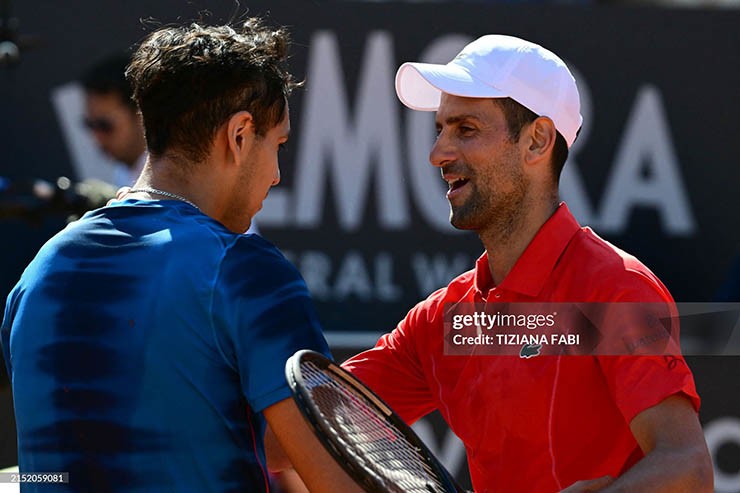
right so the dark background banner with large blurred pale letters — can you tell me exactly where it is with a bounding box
[0,0,740,491]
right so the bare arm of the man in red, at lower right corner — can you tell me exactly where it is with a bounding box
[563,395,714,493]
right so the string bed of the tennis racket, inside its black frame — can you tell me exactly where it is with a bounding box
[301,362,445,493]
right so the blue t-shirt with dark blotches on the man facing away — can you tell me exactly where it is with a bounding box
[2,200,329,492]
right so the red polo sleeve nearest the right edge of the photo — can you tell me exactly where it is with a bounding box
[597,271,701,423]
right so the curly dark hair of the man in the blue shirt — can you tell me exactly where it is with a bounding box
[126,17,300,163]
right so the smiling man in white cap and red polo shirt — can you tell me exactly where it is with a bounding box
[344,35,713,493]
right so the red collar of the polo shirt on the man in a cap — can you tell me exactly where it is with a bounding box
[475,202,581,297]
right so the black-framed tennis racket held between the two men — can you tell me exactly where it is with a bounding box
[285,350,465,493]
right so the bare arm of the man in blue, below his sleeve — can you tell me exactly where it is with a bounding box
[264,399,364,493]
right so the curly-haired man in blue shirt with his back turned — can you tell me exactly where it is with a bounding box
[1,19,356,492]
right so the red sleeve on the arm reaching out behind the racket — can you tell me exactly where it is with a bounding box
[342,303,436,424]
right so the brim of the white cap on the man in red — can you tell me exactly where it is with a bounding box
[396,62,507,111]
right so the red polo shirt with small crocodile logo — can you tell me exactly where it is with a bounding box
[343,203,699,493]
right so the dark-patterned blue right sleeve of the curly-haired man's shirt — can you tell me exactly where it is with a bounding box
[213,235,331,412]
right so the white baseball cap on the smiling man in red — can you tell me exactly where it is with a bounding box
[396,34,583,147]
